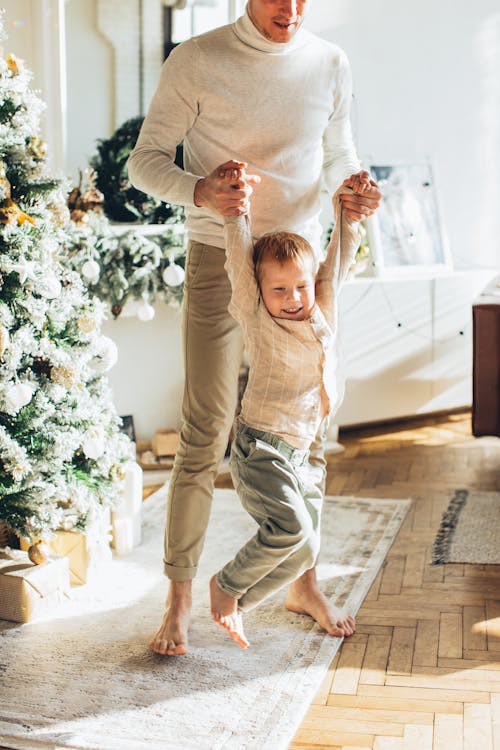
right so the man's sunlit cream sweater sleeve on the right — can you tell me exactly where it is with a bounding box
[323,50,360,195]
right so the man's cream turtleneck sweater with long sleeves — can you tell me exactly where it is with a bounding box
[128,6,359,248]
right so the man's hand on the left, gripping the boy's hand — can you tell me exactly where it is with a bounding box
[194,159,260,216]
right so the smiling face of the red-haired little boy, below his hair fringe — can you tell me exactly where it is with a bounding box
[259,258,315,320]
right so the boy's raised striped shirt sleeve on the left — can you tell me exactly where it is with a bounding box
[224,216,259,321]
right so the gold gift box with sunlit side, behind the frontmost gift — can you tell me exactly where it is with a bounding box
[20,508,112,586]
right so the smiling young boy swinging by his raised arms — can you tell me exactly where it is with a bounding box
[210,170,371,648]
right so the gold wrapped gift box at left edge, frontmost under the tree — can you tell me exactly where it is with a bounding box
[0,550,70,622]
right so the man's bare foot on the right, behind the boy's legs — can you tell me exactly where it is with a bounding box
[285,568,356,637]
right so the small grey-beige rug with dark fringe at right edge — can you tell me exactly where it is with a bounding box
[432,490,500,565]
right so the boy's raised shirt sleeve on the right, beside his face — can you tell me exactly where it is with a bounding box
[316,187,360,316]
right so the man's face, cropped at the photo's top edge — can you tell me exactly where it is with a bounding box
[248,0,308,44]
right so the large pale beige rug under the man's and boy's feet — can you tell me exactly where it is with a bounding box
[0,488,410,750]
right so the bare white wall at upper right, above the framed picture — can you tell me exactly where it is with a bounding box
[307,0,500,268]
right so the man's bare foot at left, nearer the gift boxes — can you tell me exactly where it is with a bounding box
[148,581,191,656]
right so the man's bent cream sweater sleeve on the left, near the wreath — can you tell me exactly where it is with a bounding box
[128,40,203,206]
